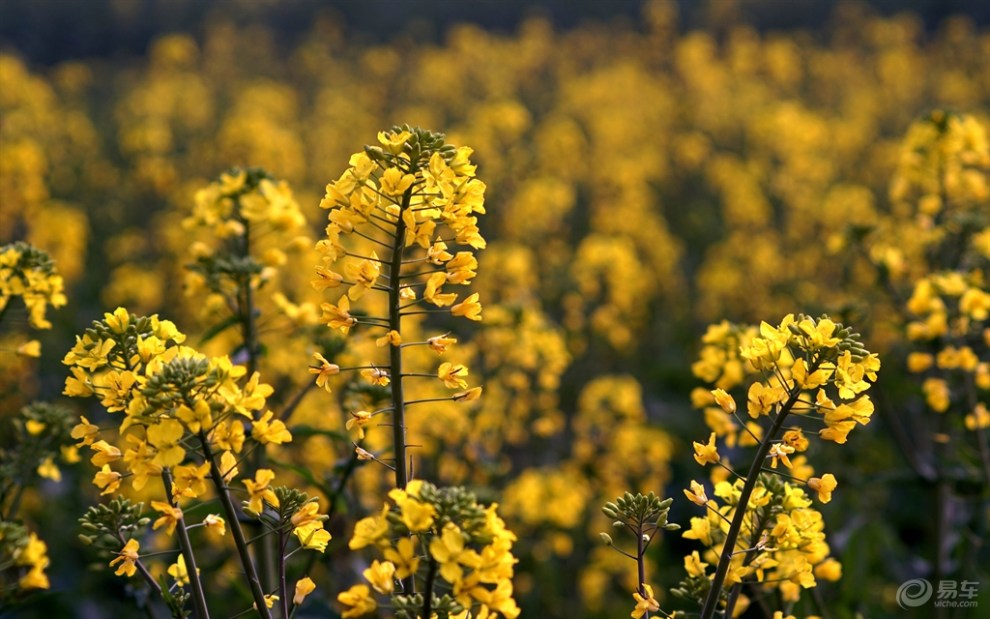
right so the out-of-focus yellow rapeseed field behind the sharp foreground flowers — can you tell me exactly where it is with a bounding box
[0,0,990,616]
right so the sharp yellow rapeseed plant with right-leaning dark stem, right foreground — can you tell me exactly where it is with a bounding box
[678,314,880,617]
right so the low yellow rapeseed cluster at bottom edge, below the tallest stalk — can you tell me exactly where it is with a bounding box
[337,479,520,619]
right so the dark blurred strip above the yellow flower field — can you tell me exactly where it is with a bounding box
[0,0,990,65]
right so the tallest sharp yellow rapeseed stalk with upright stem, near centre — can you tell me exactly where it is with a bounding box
[312,126,485,489]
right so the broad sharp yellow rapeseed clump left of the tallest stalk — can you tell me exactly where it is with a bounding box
[63,308,330,616]
